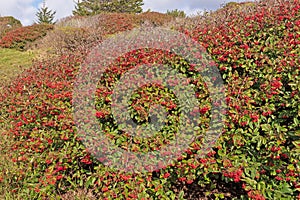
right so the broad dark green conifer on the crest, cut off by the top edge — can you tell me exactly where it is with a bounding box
[73,0,144,16]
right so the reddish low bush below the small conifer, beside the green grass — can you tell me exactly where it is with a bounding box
[0,24,53,50]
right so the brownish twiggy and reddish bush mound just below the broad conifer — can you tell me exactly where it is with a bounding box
[37,12,173,54]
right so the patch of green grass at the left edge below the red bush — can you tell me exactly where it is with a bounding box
[0,48,35,84]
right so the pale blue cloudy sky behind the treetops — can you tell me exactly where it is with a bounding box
[0,0,252,26]
